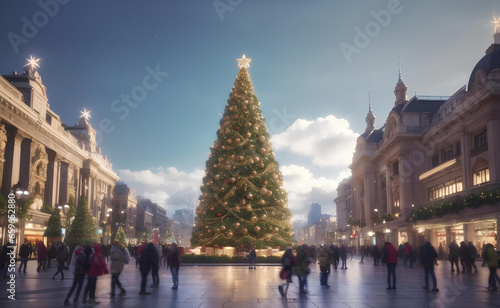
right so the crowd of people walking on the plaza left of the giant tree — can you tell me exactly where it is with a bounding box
[0,241,181,306]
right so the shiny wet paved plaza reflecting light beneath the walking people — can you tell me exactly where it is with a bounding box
[0,258,500,308]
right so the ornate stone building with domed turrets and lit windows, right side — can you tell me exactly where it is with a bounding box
[335,31,500,253]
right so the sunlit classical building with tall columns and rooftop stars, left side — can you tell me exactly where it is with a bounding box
[0,63,118,248]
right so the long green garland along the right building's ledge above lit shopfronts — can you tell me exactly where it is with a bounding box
[407,188,500,222]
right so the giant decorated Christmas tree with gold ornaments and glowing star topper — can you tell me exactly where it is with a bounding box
[191,55,294,248]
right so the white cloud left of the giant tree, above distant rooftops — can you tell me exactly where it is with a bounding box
[118,167,205,215]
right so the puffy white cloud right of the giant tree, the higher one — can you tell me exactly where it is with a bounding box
[271,115,359,167]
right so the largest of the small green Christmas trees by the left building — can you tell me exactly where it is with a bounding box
[64,198,99,248]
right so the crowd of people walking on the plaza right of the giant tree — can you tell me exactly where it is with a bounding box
[278,241,500,297]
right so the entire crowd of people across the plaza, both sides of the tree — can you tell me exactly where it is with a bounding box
[0,241,500,305]
